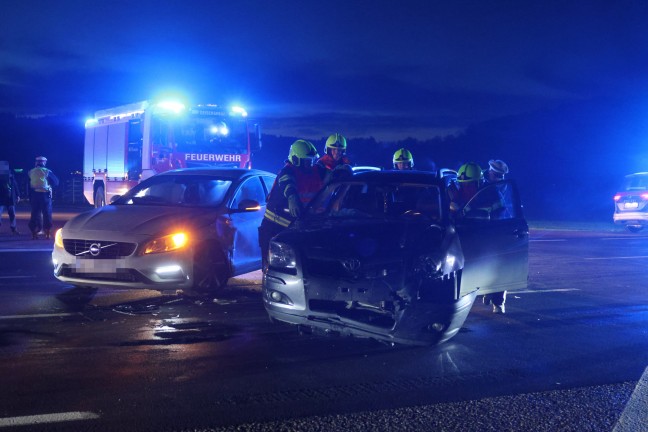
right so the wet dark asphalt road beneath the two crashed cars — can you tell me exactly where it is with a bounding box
[0,214,648,431]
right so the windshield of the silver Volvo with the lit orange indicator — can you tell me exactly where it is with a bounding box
[114,175,232,207]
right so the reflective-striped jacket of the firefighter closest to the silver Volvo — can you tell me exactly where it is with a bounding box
[263,163,327,227]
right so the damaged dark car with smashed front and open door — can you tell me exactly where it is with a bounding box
[263,171,528,345]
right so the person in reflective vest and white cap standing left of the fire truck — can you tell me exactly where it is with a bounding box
[28,156,59,240]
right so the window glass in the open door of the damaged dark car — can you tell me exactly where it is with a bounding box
[463,182,519,220]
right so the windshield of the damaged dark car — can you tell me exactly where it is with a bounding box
[308,182,441,221]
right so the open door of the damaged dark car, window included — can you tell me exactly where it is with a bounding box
[455,180,529,296]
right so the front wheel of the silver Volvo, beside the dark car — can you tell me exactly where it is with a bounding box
[192,243,229,294]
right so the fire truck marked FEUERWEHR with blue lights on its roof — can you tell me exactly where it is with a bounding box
[83,101,261,207]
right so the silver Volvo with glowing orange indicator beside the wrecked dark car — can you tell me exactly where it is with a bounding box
[52,168,275,293]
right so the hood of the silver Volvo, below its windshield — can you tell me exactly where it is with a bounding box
[64,205,223,236]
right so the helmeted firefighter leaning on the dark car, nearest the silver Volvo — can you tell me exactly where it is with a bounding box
[259,139,328,270]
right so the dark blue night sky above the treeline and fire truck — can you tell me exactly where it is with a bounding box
[5,0,648,139]
